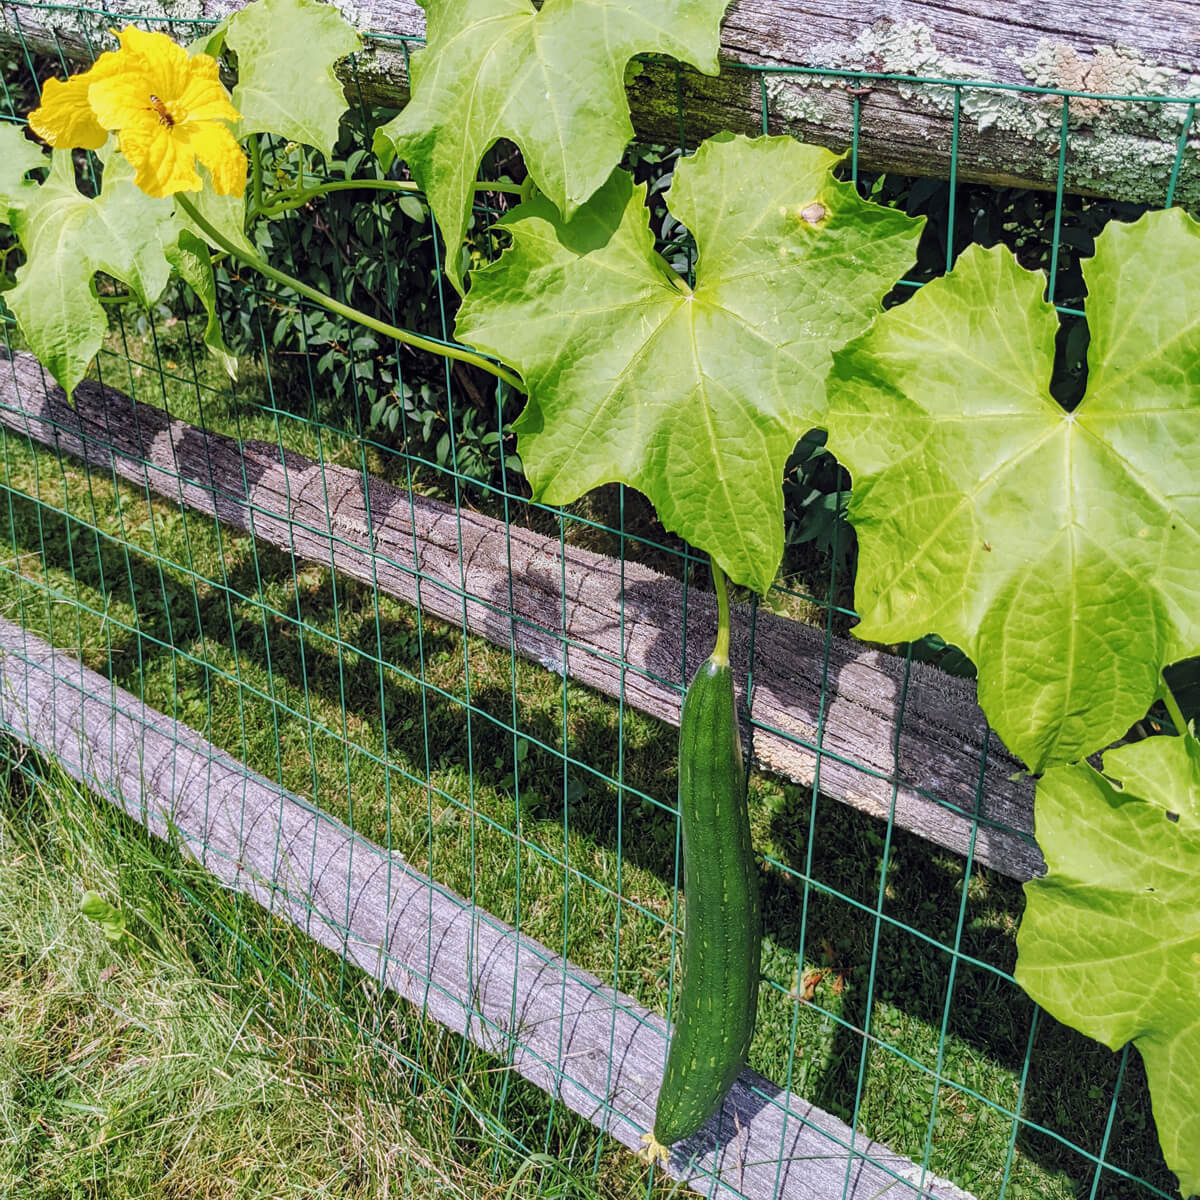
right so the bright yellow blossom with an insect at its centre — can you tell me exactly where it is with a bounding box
[29,25,246,196]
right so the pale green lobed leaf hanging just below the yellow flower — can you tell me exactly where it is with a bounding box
[5,150,174,395]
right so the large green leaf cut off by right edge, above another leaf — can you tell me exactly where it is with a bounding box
[827,210,1200,770]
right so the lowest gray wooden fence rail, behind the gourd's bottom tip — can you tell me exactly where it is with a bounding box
[0,618,970,1200]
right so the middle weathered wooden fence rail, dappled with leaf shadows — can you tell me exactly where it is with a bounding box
[0,354,1044,880]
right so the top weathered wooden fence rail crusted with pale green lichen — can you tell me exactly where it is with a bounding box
[0,0,1200,204]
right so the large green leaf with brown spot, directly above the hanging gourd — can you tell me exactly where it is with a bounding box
[457,138,922,590]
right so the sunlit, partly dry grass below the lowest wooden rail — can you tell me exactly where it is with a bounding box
[0,748,696,1200]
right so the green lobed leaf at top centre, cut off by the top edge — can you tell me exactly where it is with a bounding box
[376,0,728,290]
